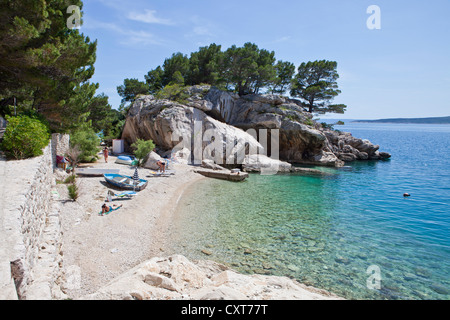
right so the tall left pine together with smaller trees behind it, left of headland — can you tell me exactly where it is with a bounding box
[0,0,124,158]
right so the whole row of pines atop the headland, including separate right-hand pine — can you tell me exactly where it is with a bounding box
[117,42,346,114]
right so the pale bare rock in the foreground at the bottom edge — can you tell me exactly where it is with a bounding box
[82,255,341,300]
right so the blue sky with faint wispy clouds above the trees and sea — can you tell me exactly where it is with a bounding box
[80,0,450,119]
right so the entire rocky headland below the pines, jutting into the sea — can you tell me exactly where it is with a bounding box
[122,86,390,167]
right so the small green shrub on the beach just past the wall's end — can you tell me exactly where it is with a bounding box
[70,126,100,162]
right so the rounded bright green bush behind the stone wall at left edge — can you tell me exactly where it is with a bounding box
[1,115,50,159]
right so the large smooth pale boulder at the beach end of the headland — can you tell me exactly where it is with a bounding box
[122,96,263,168]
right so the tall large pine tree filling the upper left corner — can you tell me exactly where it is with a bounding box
[0,0,97,131]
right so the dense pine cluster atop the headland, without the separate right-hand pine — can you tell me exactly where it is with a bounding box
[141,42,292,97]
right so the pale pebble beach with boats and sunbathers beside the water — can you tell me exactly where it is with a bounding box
[57,156,205,299]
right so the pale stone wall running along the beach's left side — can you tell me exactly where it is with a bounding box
[0,135,68,300]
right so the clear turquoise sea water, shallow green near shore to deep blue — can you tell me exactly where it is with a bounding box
[169,123,450,299]
